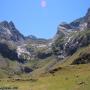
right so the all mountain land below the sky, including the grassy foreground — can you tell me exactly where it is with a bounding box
[0,9,90,90]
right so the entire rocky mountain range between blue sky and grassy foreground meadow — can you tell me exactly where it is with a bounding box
[0,9,90,81]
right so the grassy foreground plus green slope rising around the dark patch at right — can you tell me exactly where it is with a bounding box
[0,46,90,90]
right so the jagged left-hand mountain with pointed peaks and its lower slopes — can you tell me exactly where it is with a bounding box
[0,21,49,77]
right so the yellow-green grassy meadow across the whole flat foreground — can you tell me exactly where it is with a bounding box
[0,64,90,90]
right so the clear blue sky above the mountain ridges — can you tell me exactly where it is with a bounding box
[0,0,90,38]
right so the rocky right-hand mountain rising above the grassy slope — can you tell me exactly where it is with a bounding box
[52,9,90,58]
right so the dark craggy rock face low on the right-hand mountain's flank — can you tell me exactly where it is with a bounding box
[64,30,90,55]
